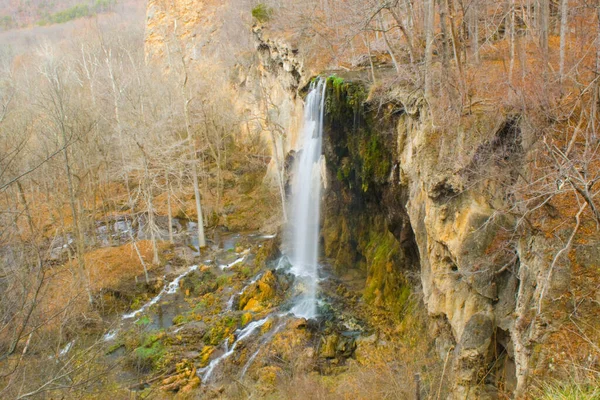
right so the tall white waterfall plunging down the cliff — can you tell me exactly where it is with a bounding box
[289,79,327,318]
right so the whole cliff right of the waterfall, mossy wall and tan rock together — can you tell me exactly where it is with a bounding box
[323,78,596,399]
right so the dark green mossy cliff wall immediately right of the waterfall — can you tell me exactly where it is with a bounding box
[322,75,412,315]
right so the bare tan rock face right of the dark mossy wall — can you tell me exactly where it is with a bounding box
[397,102,531,398]
